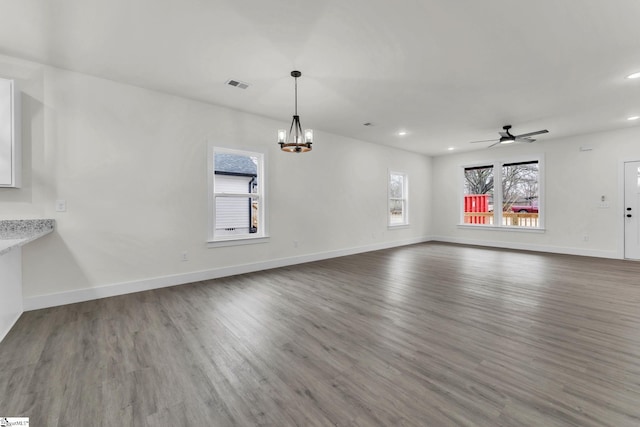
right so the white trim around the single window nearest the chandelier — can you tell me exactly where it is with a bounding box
[207,143,269,244]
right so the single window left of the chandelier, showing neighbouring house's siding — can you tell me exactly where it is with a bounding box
[209,147,265,242]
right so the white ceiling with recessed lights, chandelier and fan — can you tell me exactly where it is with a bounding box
[0,0,640,155]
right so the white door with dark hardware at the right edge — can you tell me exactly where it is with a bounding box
[624,162,640,260]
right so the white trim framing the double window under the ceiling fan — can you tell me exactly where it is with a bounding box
[457,154,547,233]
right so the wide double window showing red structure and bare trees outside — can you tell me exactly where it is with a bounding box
[462,159,543,229]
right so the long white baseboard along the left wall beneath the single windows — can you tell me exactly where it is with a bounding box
[24,237,432,311]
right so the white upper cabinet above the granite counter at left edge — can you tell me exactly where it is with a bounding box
[0,78,22,187]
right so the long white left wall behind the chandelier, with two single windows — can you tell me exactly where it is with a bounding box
[0,61,431,308]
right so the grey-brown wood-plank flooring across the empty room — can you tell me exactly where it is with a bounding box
[0,243,640,427]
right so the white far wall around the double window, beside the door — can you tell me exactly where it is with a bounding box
[432,127,640,258]
